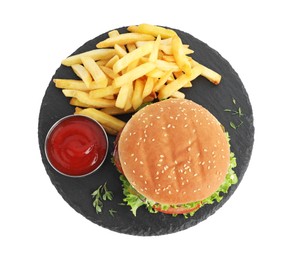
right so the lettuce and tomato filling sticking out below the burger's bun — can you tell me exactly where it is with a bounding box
[113,133,238,217]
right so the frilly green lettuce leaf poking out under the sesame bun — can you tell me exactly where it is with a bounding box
[120,133,238,218]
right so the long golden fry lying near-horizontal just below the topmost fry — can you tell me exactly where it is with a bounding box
[96,33,155,48]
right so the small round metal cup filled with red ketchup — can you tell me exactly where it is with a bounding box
[45,115,108,177]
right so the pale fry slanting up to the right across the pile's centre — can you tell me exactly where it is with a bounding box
[114,62,156,87]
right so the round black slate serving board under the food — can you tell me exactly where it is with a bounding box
[38,27,254,236]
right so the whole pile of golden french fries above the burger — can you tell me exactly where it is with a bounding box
[54,24,221,135]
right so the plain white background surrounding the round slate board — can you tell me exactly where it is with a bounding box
[0,0,289,260]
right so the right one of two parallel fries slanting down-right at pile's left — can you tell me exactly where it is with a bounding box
[81,56,108,87]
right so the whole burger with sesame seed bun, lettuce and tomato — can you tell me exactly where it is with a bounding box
[114,99,237,217]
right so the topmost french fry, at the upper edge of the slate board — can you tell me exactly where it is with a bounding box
[127,24,176,38]
